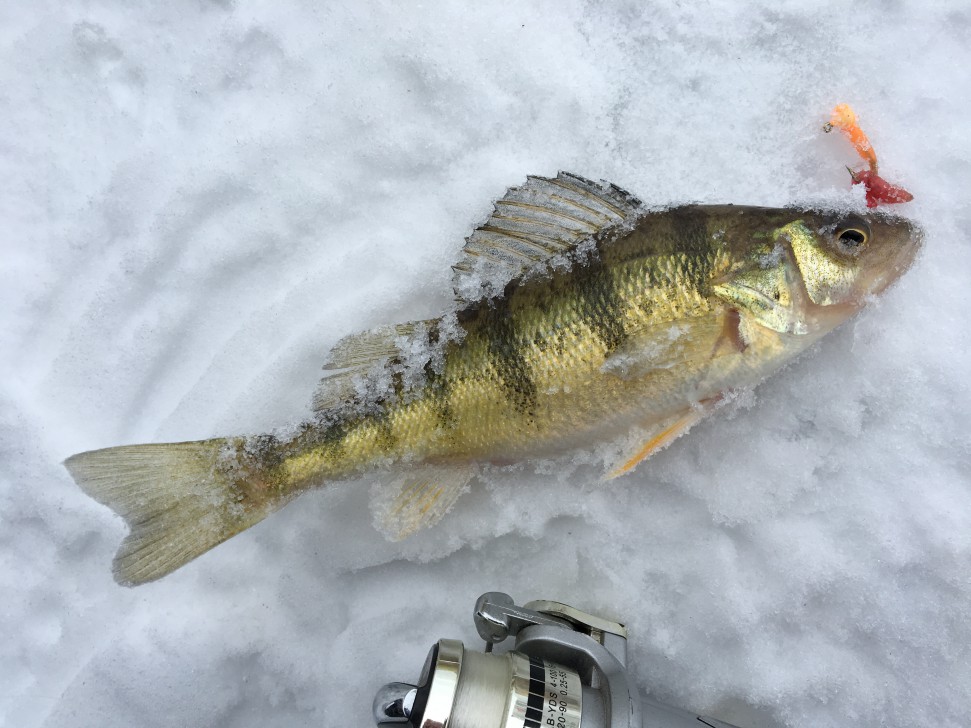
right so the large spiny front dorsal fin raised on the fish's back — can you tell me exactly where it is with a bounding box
[452,172,642,302]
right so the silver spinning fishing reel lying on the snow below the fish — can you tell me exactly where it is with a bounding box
[374,592,737,728]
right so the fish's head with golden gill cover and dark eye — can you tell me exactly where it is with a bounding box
[715,210,922,336]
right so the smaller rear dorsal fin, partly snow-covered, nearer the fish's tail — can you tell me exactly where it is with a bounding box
[313,319,439,412]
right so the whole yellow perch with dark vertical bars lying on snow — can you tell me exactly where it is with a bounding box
[64,172,922,586]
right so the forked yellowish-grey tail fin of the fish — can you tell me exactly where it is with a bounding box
[64,439,285,586]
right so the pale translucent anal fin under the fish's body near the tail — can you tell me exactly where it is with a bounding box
[372,465,475,541]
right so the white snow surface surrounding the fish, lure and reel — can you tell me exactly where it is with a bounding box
[0,0,971,728]
